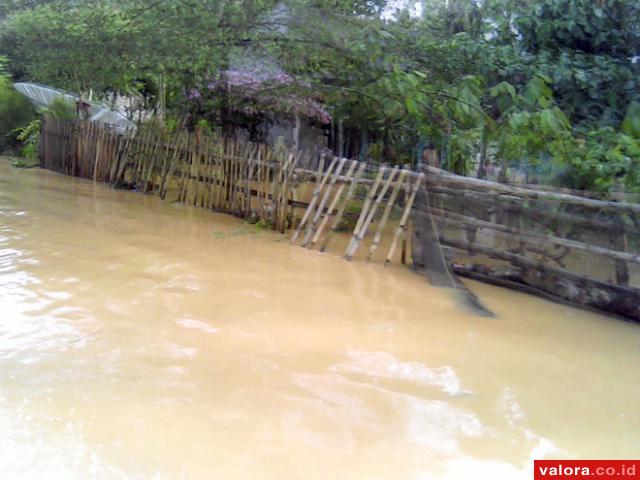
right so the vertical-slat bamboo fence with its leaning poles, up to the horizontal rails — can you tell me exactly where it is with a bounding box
[40,119,423,264]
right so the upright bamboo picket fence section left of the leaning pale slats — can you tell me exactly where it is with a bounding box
[40,120,299,232]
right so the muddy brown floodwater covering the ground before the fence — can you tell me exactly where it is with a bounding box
[0,160,640,480]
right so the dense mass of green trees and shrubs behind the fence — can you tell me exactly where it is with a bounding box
[0,0,640,192]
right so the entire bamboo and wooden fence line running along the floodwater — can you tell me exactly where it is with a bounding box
[40,119,640,319]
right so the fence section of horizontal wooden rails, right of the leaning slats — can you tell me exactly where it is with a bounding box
[414,167,640,320]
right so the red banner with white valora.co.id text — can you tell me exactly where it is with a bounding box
[533,460,640,480]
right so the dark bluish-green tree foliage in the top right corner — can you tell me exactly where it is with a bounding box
[485,0,640,128]
